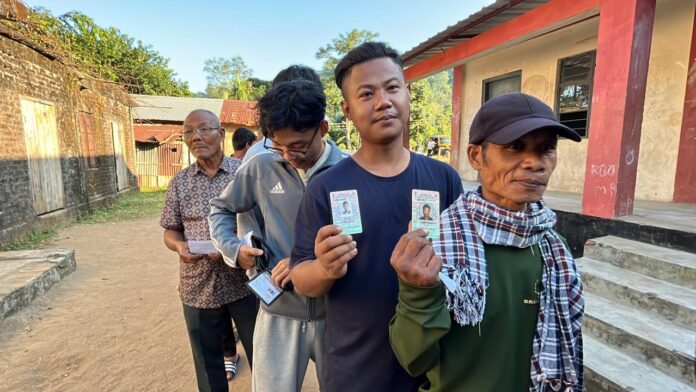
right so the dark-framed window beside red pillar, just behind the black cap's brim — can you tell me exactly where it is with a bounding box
[556,51,595,138]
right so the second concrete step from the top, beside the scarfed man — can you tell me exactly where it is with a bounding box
[577,257,696,329]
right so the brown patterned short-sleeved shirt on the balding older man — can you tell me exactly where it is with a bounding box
[160,157,251,309]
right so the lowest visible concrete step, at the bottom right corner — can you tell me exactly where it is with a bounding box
[583,335,696,392]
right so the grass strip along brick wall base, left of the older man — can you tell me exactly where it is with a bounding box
[79,191,165,223]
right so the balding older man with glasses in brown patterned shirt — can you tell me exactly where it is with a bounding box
[160,110,258,391]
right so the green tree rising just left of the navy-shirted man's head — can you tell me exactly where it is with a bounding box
[316,29,379,148]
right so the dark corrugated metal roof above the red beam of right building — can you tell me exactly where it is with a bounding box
[401,0,549,67]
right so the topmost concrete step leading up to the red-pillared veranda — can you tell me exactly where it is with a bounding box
[584,236,696,290]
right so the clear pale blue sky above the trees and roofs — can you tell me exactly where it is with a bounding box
[24,0,493,92]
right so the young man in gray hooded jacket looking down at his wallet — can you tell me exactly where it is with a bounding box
[209,72,345,392]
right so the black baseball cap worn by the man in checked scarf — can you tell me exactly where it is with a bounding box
[469,93,581,144]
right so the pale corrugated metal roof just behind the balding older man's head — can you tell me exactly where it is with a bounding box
[131,94,224,122]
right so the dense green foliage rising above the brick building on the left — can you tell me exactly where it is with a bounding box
[24,8,191,96]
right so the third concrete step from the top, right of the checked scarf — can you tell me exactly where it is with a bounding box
[583,292,696,384]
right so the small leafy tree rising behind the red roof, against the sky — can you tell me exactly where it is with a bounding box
[203,56,271,101]
